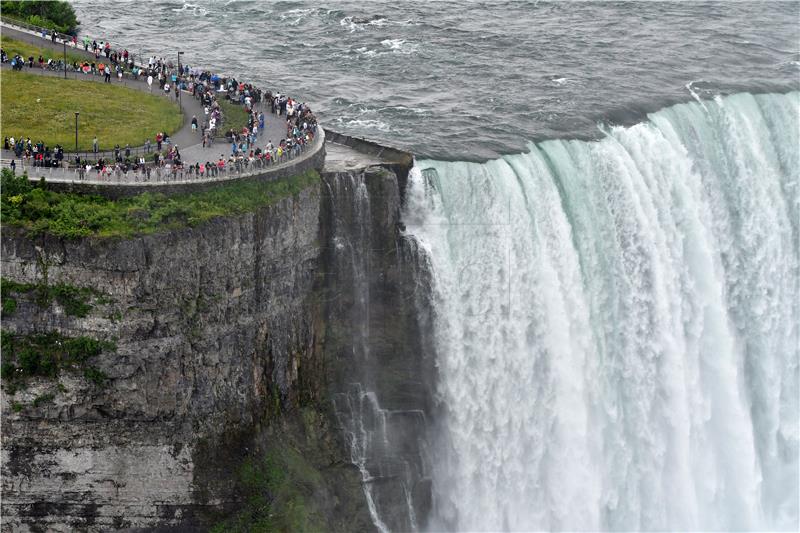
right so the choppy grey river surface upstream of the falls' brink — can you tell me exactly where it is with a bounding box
[73,0,800,161]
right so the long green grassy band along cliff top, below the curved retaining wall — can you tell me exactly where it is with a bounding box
[0,169,319,238]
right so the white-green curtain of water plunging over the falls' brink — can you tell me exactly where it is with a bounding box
[404,93,800,531]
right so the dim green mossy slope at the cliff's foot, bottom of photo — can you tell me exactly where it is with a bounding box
[206,406,372,533]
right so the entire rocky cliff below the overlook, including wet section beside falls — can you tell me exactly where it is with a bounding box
[2,164,429,531]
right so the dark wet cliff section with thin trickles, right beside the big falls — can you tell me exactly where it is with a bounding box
[321,167,435,531]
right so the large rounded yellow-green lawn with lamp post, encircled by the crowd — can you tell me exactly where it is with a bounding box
[0,70,183,151]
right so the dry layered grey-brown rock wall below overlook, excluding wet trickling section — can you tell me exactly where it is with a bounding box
[2,187,324,531]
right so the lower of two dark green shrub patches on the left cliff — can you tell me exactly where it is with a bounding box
[2,331,116,394]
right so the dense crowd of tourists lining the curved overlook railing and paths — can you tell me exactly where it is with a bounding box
[1,21,317,179]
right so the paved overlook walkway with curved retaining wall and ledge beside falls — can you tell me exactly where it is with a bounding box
[0,20,413,198]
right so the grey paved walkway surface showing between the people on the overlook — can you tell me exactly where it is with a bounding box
[0,22,286,163]
